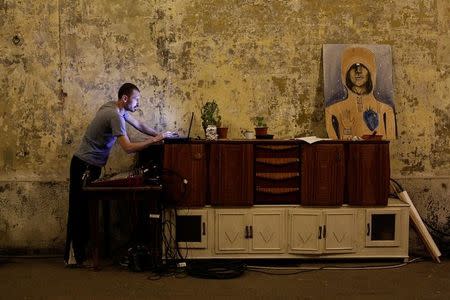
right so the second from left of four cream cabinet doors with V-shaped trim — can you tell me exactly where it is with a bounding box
[249,209,286,253]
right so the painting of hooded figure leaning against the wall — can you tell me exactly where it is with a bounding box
[324,45,396,140]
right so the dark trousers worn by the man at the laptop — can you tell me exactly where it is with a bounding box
[64,156,101,264]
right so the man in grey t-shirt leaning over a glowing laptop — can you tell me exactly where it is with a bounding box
[64,83,174,265]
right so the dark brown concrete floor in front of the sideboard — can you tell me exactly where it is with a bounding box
[0,258,450,299]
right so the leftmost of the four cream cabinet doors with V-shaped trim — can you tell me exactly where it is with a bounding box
[215,209,250,253]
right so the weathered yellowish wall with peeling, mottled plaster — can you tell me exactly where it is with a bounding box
[0,0,450,253]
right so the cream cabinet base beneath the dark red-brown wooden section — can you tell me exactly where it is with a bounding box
[166,199,409,261]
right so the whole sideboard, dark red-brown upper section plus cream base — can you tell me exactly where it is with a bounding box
[141,140,409,260]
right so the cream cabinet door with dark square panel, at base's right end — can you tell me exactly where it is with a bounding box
[366,208,402,247]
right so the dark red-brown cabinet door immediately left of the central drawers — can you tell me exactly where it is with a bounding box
[210,144,253,206]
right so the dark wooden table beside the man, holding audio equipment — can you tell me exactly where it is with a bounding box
[83,185,162,271]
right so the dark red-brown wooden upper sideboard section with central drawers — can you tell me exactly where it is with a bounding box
[149,140,390,207]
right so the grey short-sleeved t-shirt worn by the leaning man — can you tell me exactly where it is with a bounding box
[74,101,128,167]
